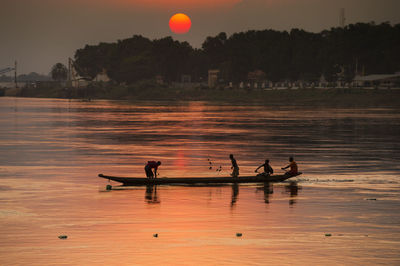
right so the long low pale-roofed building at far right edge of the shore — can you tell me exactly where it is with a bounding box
[353,72,400,87]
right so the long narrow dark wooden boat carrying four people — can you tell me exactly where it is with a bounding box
[99,173,301,186]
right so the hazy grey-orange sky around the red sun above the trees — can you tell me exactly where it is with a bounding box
[0,0,400,74]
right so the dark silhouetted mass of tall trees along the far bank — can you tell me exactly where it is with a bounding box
[75,23,400,84]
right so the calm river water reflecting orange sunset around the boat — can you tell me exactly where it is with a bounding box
[0,97,400,265]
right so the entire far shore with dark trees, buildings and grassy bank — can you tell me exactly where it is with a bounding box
[0,22,400,106]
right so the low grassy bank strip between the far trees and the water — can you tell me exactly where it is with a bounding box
[4,84,400,106]
